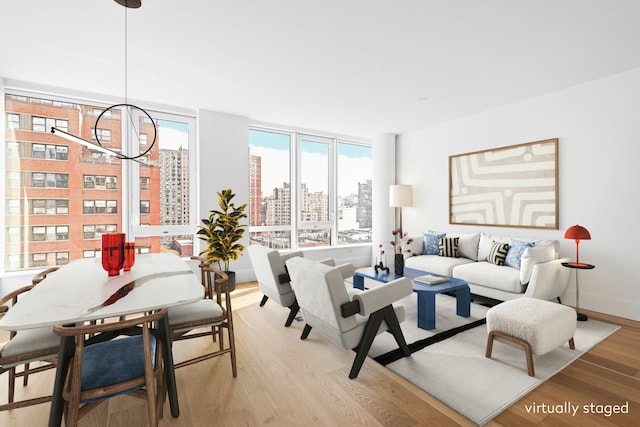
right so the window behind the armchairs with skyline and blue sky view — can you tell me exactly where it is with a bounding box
[249,127,373,249]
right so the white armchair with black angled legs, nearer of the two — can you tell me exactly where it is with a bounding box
[286,258,413,379]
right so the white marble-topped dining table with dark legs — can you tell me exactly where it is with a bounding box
[0,253,204,426]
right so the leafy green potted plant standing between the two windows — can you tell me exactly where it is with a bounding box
[197,189,247,290]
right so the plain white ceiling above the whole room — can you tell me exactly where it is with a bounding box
[0,0,640,137]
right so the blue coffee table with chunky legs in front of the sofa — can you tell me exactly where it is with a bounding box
[353,267,471,329]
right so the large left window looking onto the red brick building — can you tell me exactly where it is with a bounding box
[0,90,199,272]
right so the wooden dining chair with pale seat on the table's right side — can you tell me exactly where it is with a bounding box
[167,257,238,378]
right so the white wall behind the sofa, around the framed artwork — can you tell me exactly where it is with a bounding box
[396,69,640,320]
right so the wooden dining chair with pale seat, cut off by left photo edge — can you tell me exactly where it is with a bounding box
[0,285,60,411]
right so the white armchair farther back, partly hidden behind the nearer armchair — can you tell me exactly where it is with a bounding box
[247,245,304,327]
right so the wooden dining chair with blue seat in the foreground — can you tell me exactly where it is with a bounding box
[53,308,168,427]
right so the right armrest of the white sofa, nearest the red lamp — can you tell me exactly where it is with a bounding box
[524,258,571,300]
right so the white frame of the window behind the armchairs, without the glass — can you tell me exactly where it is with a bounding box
[248,124,373,250]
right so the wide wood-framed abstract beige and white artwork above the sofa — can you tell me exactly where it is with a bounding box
[449,138,558,230]
